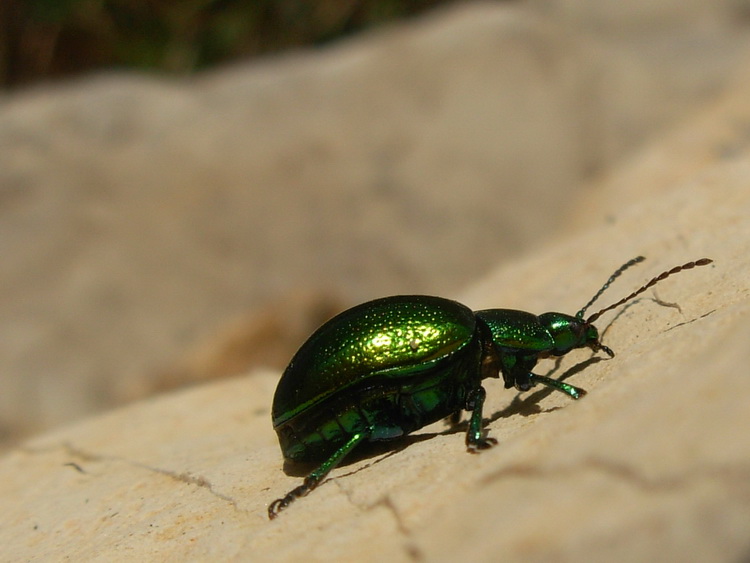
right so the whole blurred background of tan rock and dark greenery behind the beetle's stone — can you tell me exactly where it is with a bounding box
[0,0,750,446]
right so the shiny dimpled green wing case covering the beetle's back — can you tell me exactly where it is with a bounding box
[272,296,476,428]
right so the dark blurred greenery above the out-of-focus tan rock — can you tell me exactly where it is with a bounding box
[0,0,464,88]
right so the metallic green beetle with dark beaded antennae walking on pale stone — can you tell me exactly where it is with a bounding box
[268,256,712,519]
